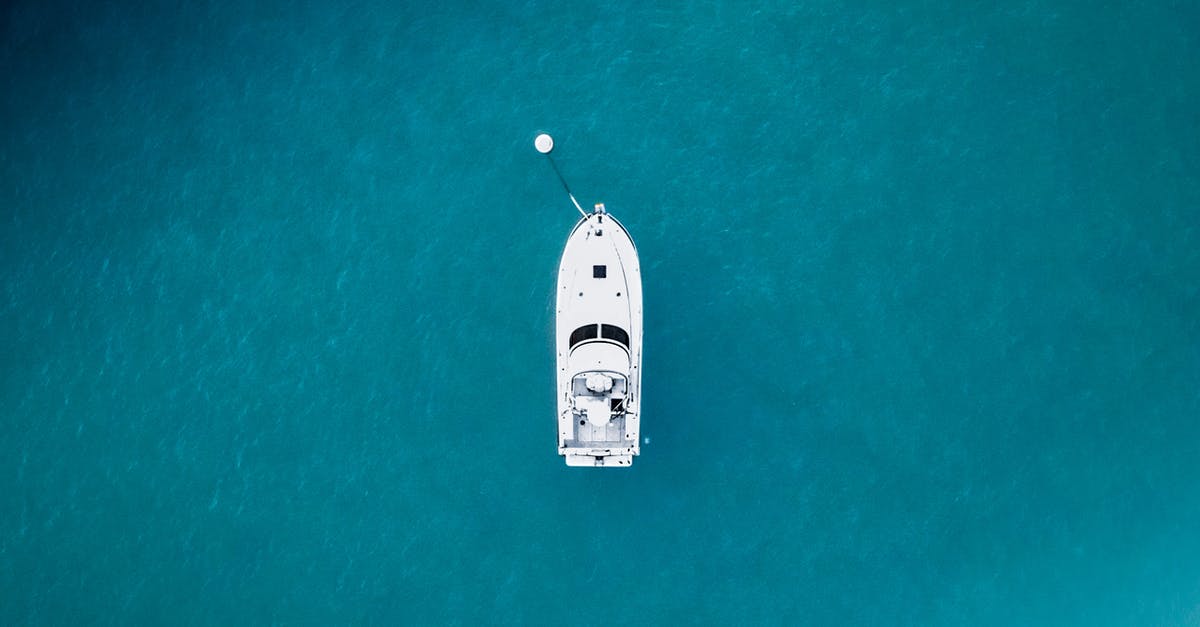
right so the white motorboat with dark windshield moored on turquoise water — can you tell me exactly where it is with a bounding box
[554,202,642,466]
